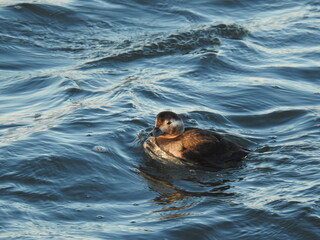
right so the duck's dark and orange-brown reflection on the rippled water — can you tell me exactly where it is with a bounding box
[139,160,242,220]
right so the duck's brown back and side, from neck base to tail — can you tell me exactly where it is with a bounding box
[155,128,249,168]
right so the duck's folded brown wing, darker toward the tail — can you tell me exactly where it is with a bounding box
[181,129,249,168]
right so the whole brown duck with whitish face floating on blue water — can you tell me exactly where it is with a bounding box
[143,111,250,168]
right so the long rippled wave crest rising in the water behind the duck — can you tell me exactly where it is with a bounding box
[82,24,248,66]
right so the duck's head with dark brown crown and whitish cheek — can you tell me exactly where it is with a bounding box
[150,111,184,138]
